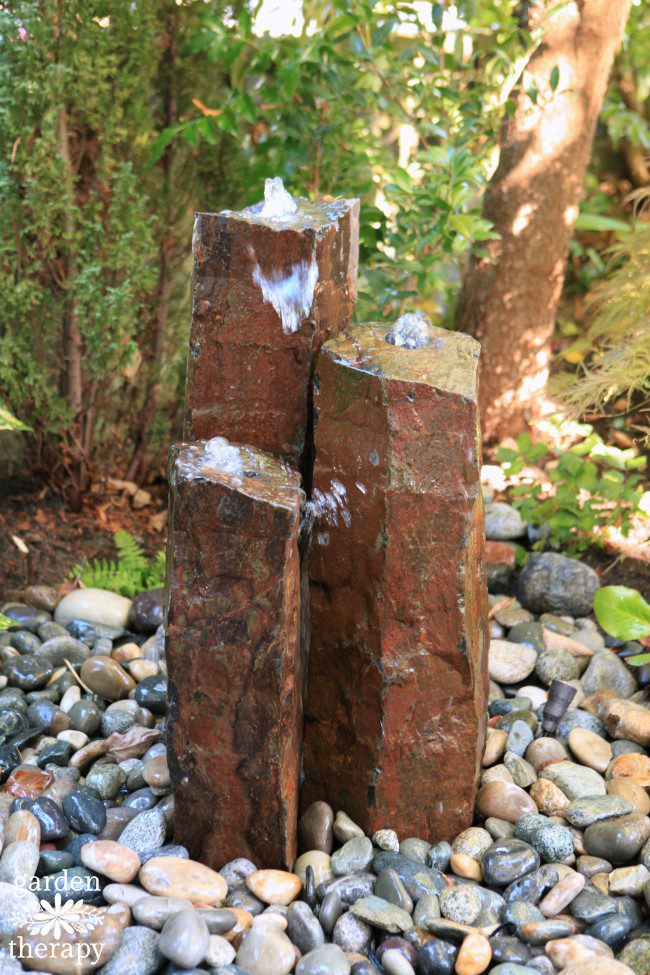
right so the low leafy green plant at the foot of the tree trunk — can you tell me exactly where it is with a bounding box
[497,424,645,554]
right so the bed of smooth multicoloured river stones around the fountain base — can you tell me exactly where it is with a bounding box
[0,548,650,975]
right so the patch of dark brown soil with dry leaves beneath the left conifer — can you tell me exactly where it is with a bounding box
[0,480,167,600]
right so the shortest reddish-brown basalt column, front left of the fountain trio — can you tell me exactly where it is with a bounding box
[165,438,304,869]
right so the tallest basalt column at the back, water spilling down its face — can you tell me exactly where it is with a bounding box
[185,200,359,467]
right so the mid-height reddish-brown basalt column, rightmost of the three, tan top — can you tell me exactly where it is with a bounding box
[303,324,488,841]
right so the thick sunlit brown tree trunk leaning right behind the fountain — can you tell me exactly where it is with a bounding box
[456,0,631,441]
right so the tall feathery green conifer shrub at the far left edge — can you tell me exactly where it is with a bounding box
[0,0,156,480]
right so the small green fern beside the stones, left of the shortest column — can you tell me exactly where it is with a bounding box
[70,531,165,599]
